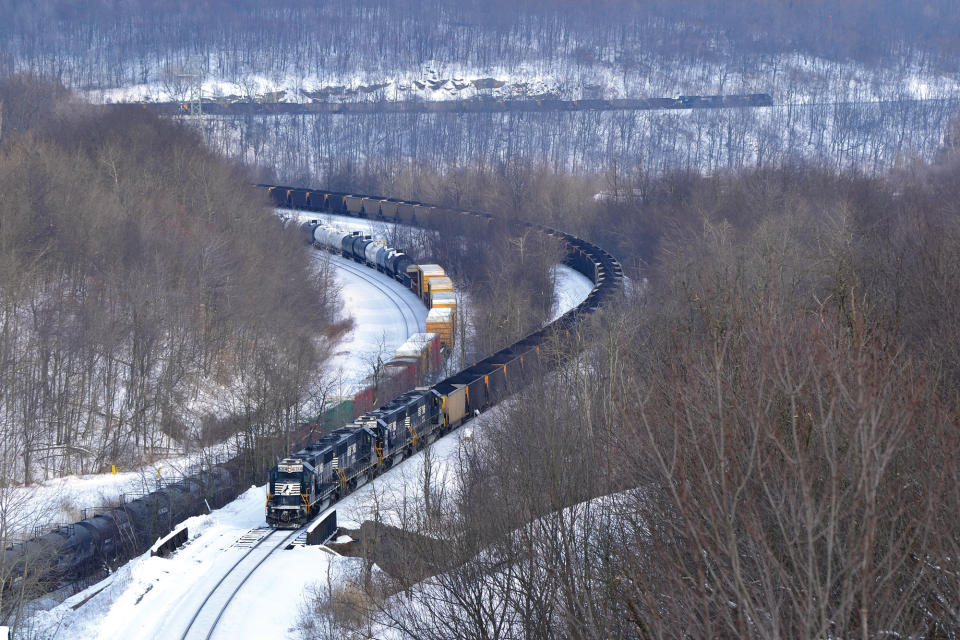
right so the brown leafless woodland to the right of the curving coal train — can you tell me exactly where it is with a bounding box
[301,138,960,638]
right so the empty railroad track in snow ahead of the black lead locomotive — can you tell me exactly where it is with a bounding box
[180,529,300,640]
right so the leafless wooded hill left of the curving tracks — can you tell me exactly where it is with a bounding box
[0,78,336,483]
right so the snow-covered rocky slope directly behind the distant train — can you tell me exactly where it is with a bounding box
[84,54,960,104]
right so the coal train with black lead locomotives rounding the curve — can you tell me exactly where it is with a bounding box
[265,187,623,529]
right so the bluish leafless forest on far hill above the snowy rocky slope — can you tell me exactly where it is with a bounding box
[0,0,960,99]
